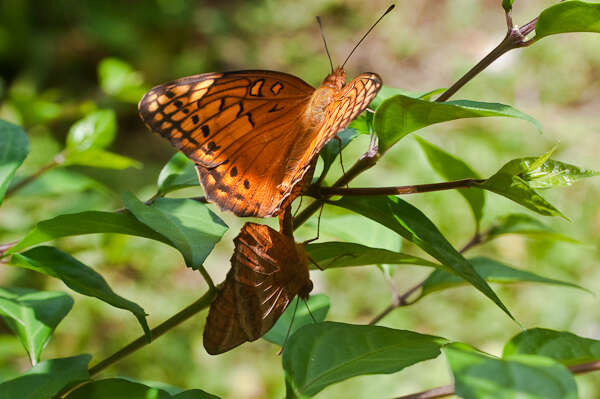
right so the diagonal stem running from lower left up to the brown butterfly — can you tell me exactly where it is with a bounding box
[89,289,216,377]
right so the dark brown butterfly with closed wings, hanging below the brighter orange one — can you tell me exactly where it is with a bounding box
[204,223,313,355]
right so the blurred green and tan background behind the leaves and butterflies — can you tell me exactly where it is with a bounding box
[0,0,600,398]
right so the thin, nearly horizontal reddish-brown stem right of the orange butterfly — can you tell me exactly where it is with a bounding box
[317,179,485,196]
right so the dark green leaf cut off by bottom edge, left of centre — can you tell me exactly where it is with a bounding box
[66,378,219,399]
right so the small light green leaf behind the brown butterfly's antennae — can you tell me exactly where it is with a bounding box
[263,294,331,346]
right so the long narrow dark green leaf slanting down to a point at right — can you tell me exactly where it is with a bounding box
[332,196,513,318]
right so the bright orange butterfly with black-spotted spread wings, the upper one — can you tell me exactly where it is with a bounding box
[138,67,381,217]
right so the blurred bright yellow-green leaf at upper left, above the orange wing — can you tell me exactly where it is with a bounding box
[98,58,147,104]
